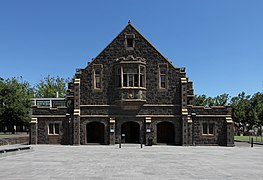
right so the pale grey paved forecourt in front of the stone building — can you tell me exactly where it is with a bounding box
[0,144,263,180]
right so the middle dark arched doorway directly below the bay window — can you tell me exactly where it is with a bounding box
[121,121,140,143]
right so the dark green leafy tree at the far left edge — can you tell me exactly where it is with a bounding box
[0,77,33,130]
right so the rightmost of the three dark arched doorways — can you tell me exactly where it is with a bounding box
[157,122,174,144]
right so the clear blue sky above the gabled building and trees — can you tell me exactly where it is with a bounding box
[0,0,263,96]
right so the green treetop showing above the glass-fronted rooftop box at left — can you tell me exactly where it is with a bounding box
[35,75,69,98]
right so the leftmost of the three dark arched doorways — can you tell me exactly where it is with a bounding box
[86,122,104,144]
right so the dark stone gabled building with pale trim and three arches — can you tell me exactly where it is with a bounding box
[30,23,234,146]
